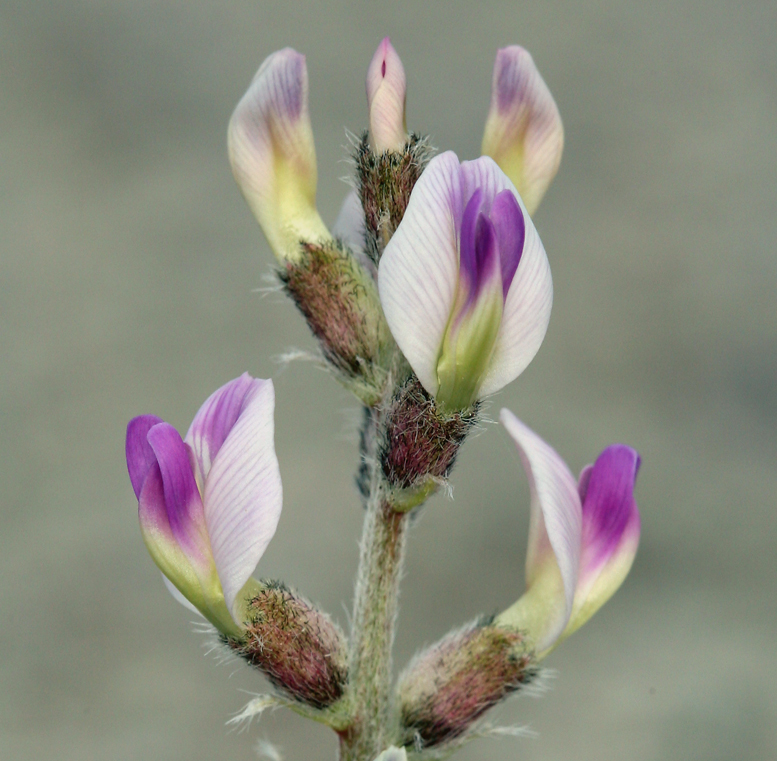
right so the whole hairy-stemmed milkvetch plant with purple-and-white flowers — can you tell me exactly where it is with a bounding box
[126,38,640,761]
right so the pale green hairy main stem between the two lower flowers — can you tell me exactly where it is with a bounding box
[340,416,408,761]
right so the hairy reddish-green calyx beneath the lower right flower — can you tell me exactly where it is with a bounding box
[398,622,536,750]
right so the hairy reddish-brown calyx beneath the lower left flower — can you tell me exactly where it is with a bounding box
[227,582,348,709]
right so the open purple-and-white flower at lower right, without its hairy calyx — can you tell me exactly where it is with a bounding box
[495,409,640,657]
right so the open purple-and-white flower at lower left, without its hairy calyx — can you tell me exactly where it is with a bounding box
[126,373,282,635]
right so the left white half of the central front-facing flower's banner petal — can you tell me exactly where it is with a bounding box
[378,151,464,395]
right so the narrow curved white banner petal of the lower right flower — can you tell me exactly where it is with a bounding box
[497,409,582,653]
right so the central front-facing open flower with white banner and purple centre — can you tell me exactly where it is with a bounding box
[378,151,553,409]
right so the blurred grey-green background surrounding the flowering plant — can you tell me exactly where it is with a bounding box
[0,0,777,761]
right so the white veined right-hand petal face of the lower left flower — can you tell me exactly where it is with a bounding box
[203,379,283,624]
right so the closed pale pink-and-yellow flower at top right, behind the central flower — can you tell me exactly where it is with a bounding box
[481,45,564,214]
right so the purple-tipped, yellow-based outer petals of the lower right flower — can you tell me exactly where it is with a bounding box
[563,444,640,638]
